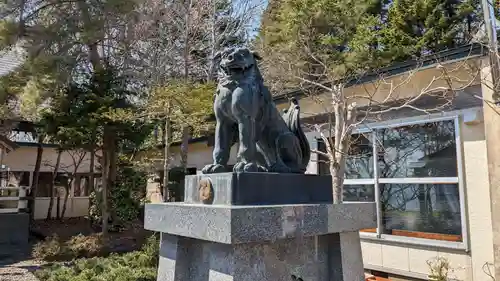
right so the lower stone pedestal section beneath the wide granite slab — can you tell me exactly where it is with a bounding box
[157,232,364,281]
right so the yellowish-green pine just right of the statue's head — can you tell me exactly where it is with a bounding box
[256,0,384,92]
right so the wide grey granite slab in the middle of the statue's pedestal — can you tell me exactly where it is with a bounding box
[144,203,376,244]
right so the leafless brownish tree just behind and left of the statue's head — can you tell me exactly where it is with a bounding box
[129,0,264,200]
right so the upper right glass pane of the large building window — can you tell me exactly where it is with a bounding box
[377,120,457,178]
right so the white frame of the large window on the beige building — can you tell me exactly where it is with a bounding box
[317,108,468,251]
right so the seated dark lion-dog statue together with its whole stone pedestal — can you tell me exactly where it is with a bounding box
[144,49,376,281]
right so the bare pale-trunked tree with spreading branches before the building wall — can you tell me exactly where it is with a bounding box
[279,42,479,203]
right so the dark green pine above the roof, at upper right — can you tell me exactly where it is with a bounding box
[382,0,480,61]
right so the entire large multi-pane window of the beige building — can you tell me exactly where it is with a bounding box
[318,117,464,242]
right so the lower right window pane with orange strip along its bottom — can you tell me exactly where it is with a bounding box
[380,184,462,242]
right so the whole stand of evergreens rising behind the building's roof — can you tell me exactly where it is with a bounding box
[256,0,482,93]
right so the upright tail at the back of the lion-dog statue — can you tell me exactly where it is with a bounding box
[283,99,311,173]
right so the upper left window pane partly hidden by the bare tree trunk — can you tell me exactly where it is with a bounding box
[318,133,373,179]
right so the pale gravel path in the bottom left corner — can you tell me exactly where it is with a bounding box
[0,260,40,281]
